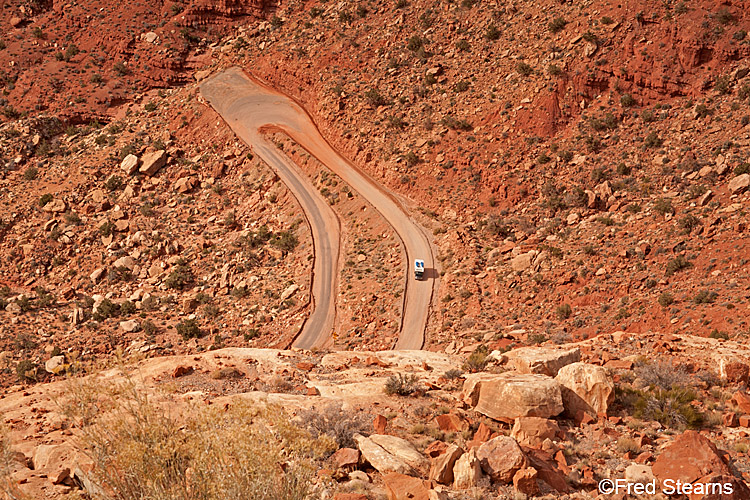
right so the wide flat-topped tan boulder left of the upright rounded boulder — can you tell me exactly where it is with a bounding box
[467,372,563,422]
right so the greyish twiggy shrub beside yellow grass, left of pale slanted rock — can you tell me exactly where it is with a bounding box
[297,403,372,448]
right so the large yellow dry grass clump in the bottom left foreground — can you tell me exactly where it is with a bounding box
[64,376,335,500]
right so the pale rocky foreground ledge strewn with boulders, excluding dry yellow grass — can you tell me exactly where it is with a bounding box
[5,332,750,500]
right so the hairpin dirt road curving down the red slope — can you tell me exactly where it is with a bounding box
[200,68,437,349]
